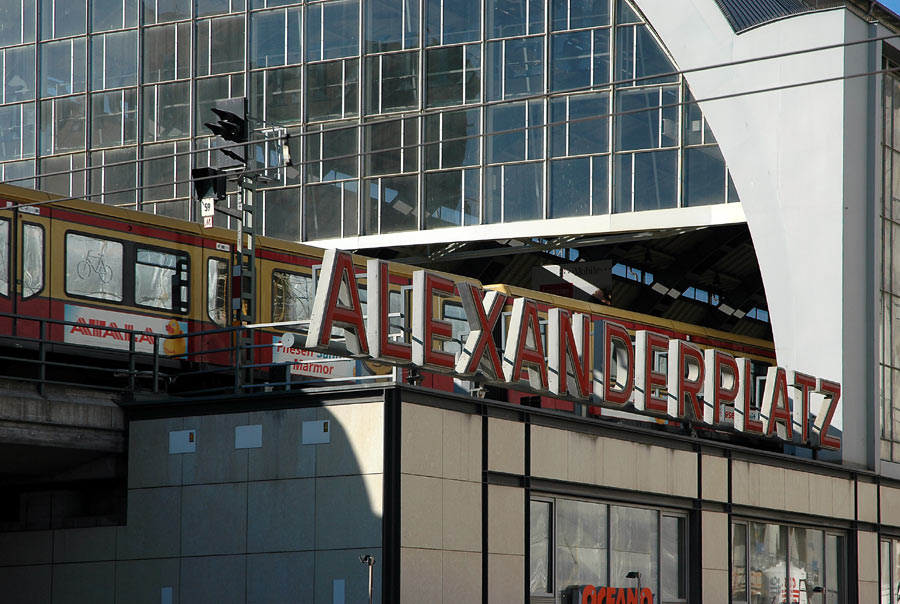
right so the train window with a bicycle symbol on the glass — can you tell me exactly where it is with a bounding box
[66,233,123,302]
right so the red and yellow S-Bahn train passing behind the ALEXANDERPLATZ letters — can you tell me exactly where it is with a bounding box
[0,185,775,409]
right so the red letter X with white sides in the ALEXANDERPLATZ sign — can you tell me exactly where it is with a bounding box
[456,283,506,380]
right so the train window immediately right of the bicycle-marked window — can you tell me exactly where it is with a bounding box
[134,248,188,312]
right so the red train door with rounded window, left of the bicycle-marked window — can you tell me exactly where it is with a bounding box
[13,208,50,338]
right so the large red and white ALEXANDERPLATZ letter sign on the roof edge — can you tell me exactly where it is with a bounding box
[306,250,841,450]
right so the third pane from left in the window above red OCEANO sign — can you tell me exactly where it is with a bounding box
[608,506,659,601]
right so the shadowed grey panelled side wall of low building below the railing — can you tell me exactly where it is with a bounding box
[0,403,384,604]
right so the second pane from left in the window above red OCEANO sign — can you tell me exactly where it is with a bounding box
[556,499,609,593]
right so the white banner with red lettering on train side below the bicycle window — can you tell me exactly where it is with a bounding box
[63,304,187,356]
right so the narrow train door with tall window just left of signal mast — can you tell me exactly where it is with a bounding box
[201,243,231,365]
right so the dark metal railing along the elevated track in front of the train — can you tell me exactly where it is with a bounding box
[0,313,397,400]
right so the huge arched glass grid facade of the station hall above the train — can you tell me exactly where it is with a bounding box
[0,0,737,240]
